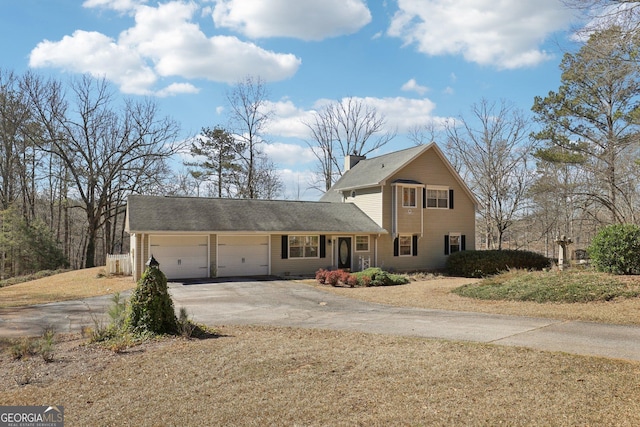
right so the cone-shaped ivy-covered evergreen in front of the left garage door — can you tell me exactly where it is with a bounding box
[127,257,178,334]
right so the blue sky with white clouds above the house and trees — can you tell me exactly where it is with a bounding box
[0,0,592,199]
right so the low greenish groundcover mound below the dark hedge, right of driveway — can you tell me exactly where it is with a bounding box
[452,270,640,303]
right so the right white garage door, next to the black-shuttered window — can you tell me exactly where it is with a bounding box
[218,236,269,277]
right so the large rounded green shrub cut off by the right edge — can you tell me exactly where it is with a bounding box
[588,224,640,274]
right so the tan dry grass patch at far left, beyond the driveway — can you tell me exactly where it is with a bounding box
[0,267,136,308]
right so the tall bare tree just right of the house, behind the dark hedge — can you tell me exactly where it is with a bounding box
[446,99,533,249]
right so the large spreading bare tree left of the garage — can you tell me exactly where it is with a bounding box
[24,76,178,267]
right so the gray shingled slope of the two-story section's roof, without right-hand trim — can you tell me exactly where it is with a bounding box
[320,144,431,202]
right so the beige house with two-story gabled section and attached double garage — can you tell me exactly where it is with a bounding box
[126,143,477,280]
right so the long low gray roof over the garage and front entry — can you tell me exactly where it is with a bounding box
[127,195,387,234]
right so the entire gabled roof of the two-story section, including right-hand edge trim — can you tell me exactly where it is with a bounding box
[320,142,478,205]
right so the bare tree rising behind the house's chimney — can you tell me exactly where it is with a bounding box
[304,97,396,191]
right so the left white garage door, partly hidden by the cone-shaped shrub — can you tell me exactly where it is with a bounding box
[151,236,209,279]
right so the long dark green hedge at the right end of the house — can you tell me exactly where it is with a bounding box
[446,250,551,277]
